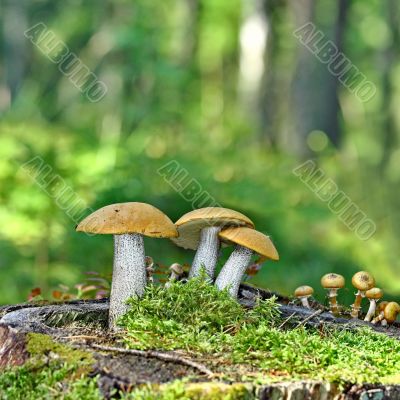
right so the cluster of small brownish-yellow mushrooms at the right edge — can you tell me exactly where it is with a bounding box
[294,271,400,326]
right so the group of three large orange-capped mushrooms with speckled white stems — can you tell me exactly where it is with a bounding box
[76,202,279,329]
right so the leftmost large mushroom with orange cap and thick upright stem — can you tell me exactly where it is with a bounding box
[76,202,178,329]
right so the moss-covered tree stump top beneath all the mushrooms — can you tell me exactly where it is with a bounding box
[0,285,400,400]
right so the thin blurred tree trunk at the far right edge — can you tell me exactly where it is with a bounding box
[380,0,400,174]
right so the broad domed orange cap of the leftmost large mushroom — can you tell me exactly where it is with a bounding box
[76,202,178,238]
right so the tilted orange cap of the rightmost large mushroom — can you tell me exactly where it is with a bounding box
[219,227,279,260]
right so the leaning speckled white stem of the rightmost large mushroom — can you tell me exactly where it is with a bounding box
[215,245,253,298]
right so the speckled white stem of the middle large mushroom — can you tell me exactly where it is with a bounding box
[189,226,221,280]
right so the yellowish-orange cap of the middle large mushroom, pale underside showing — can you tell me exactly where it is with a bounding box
[172,207,254,250]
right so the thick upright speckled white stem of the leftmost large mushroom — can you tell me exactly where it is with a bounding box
[108,233,146,330]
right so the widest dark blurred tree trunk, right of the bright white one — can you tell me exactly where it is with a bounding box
[289,0,348,156]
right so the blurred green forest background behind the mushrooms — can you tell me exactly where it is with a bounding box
[0,0,400,310]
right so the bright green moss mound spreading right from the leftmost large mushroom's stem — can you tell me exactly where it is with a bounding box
[121,279,400,384]
